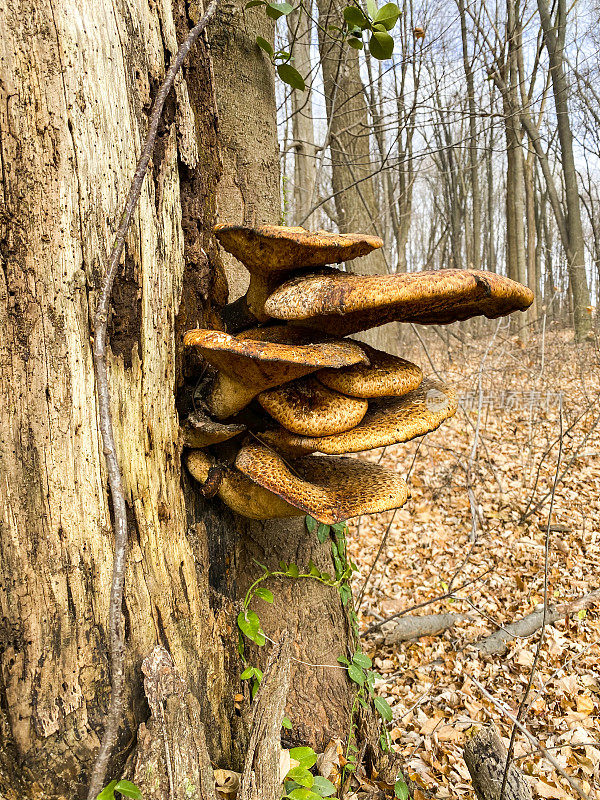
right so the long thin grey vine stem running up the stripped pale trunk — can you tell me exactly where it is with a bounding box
[88,0,217,800]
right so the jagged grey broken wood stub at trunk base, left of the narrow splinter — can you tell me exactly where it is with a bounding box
[134,646,217,800]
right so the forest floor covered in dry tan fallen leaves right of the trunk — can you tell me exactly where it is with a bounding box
[349,323,600,799]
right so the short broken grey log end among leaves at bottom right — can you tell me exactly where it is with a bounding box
[463,724,532,800]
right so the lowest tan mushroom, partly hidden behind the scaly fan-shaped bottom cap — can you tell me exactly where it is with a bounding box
[186,450,303,519]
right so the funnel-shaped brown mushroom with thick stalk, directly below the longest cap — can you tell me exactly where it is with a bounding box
[184,325,368,419]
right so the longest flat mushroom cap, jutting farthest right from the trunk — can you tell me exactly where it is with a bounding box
[264,269,533,336]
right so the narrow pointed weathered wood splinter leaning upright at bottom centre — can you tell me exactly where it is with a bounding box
[238,633,291,800]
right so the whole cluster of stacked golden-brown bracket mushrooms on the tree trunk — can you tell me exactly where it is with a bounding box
[182,225,533,524]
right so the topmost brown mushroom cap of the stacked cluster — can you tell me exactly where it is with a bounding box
[214,225,383,275]
